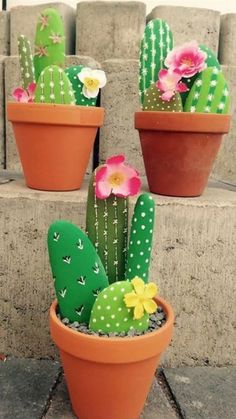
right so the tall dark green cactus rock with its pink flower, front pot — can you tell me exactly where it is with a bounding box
[86,155,141,283]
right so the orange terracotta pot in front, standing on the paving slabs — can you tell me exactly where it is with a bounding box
[50,298,174,419]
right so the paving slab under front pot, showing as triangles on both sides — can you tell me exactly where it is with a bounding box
[44,379,178,419]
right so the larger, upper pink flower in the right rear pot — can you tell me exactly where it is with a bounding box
[165,41,207,77]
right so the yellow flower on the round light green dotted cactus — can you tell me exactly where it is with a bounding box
[124,276,157,320]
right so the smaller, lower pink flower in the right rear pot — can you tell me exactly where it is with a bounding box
[156,69,188,101]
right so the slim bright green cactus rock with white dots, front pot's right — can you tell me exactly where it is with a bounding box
[126,193,155,283]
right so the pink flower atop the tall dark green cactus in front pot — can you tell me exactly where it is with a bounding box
[95,155,141,199]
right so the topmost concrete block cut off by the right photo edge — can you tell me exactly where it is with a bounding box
[219,13,236,65]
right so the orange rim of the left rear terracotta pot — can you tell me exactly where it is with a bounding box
[7,102,104,127]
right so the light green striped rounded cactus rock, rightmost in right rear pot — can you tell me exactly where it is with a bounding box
[184,67,229,114]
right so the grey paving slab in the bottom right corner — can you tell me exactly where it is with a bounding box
[164,366,236,419]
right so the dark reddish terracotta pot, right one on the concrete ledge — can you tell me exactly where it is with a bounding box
[135,111,231,197]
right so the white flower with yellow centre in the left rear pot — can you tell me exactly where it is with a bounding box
[77,67,107,99]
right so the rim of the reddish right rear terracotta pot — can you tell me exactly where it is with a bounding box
[135,111,231,134]
